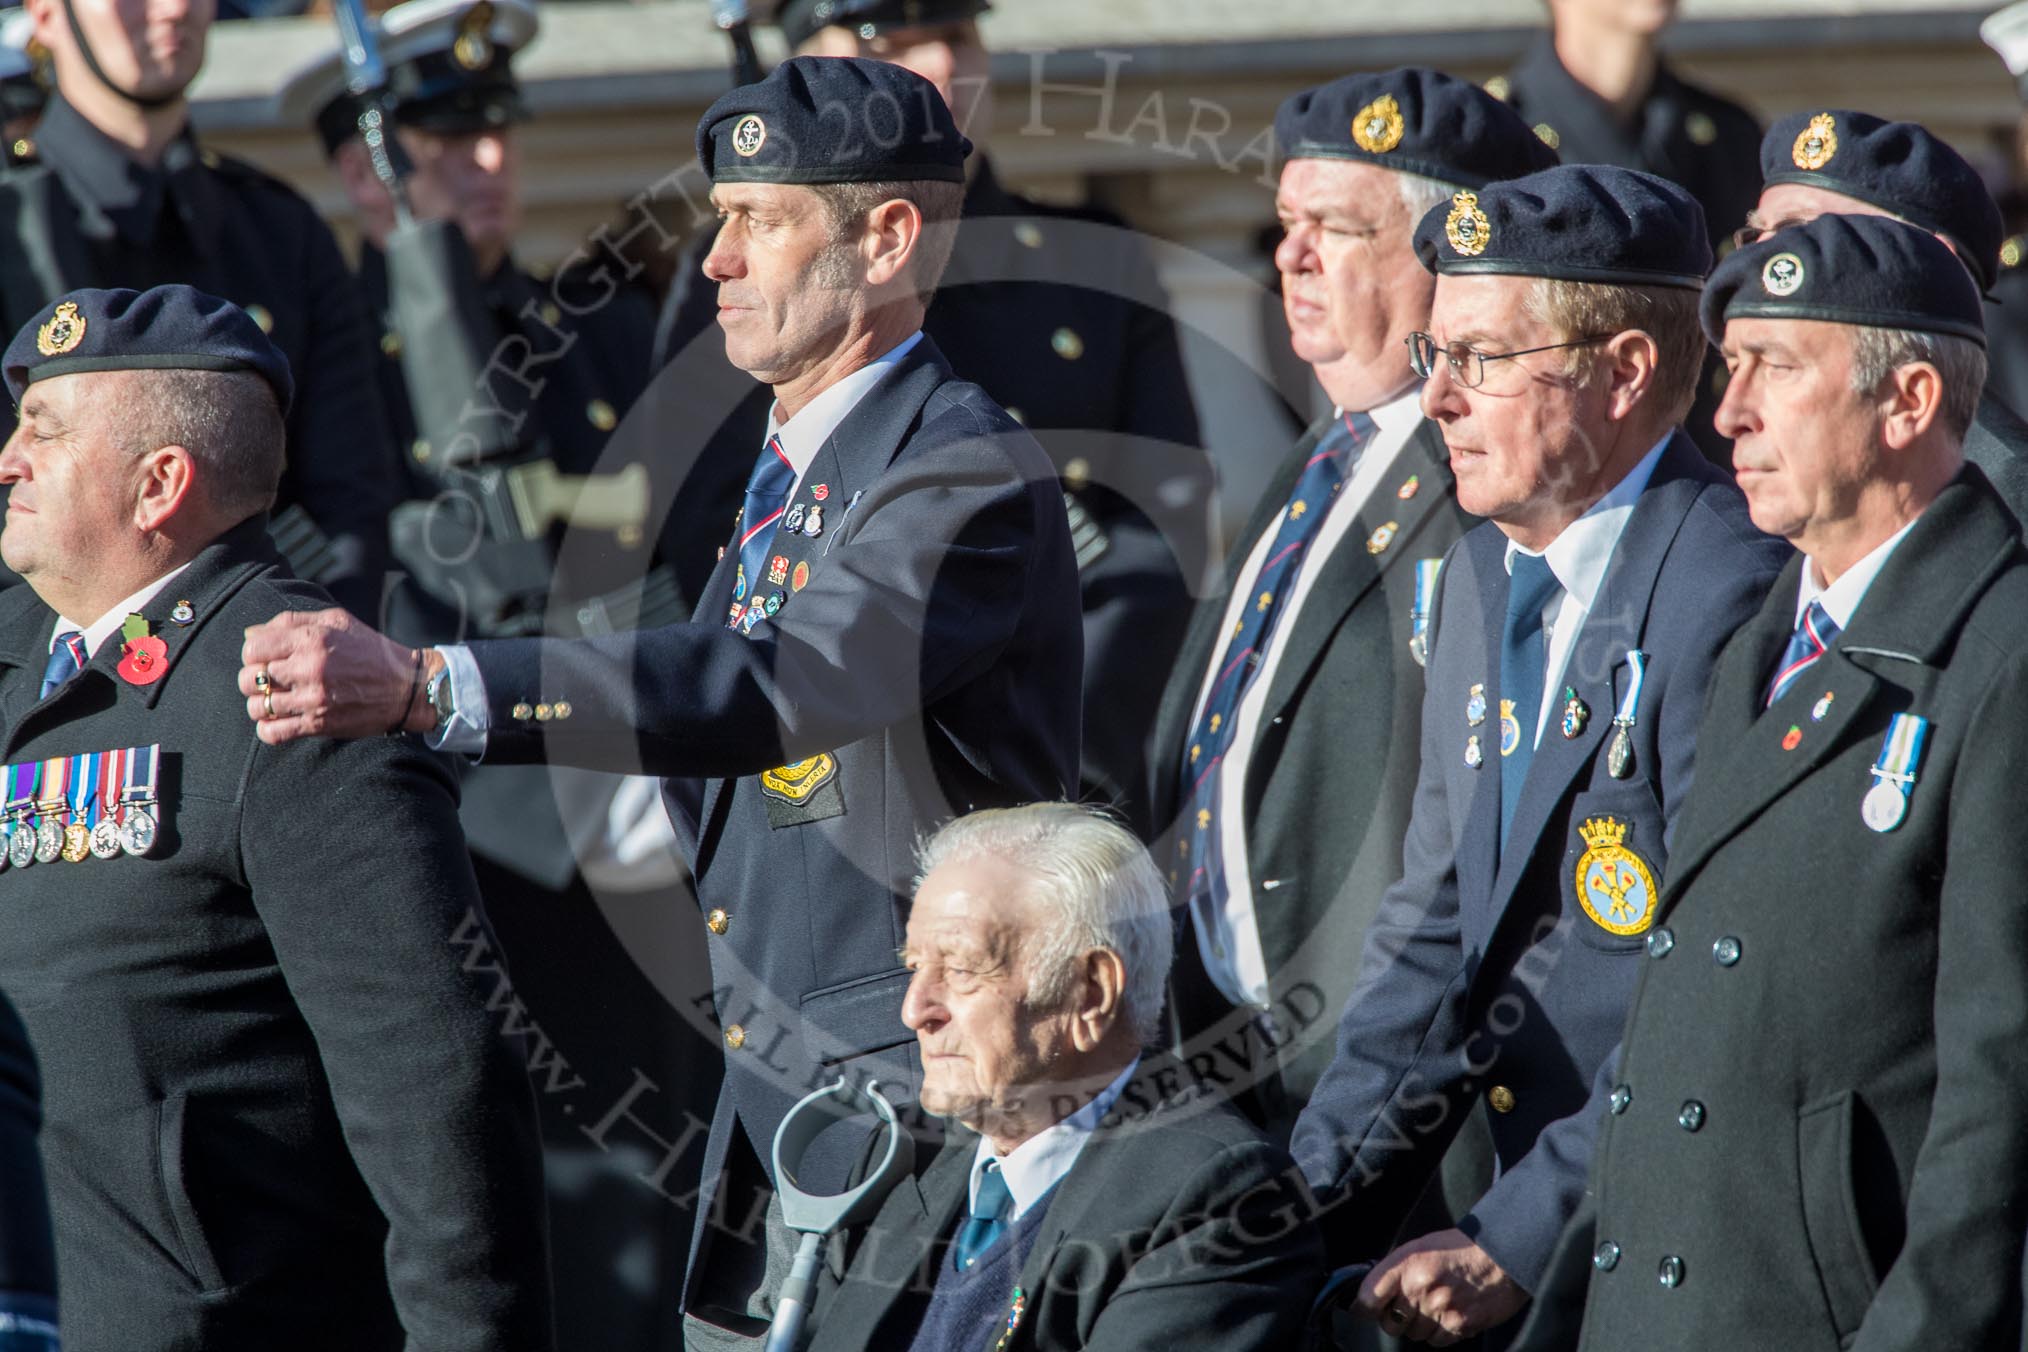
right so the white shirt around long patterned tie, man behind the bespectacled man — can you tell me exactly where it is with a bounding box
[1190,387,1422,1007]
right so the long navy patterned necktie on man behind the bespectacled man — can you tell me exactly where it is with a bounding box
[1176,414,1373,934]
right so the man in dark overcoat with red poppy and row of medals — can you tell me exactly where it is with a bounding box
[0,286,552,1352]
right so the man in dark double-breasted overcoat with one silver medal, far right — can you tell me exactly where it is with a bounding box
[1541,208,2028,1352]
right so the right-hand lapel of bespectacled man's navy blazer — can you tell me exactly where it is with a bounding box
[1493,432,1708,914]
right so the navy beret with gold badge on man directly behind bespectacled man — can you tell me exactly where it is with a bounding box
[1274,65,1555,189]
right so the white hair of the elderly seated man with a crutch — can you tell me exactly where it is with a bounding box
[915,803,1176,1044]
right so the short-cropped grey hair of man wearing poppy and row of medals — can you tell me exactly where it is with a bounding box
[105,369,286,517]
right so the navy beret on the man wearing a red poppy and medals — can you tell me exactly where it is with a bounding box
[6,284,296,414]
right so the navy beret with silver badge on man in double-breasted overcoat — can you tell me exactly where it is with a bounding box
[1697,215,1985,347]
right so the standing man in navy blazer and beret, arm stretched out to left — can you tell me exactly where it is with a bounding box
[241,57,1083,1348]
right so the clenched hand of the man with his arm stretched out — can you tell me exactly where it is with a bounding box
[239,608,444,746]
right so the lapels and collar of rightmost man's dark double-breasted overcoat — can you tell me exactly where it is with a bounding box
[1655,464,2022,922]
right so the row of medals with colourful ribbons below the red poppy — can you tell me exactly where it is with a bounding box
[0,746,162,870]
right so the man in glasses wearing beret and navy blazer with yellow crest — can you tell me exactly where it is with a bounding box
[1292,166,1787,1342]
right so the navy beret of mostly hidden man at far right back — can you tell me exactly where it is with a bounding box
[1760,107,2008,286]
